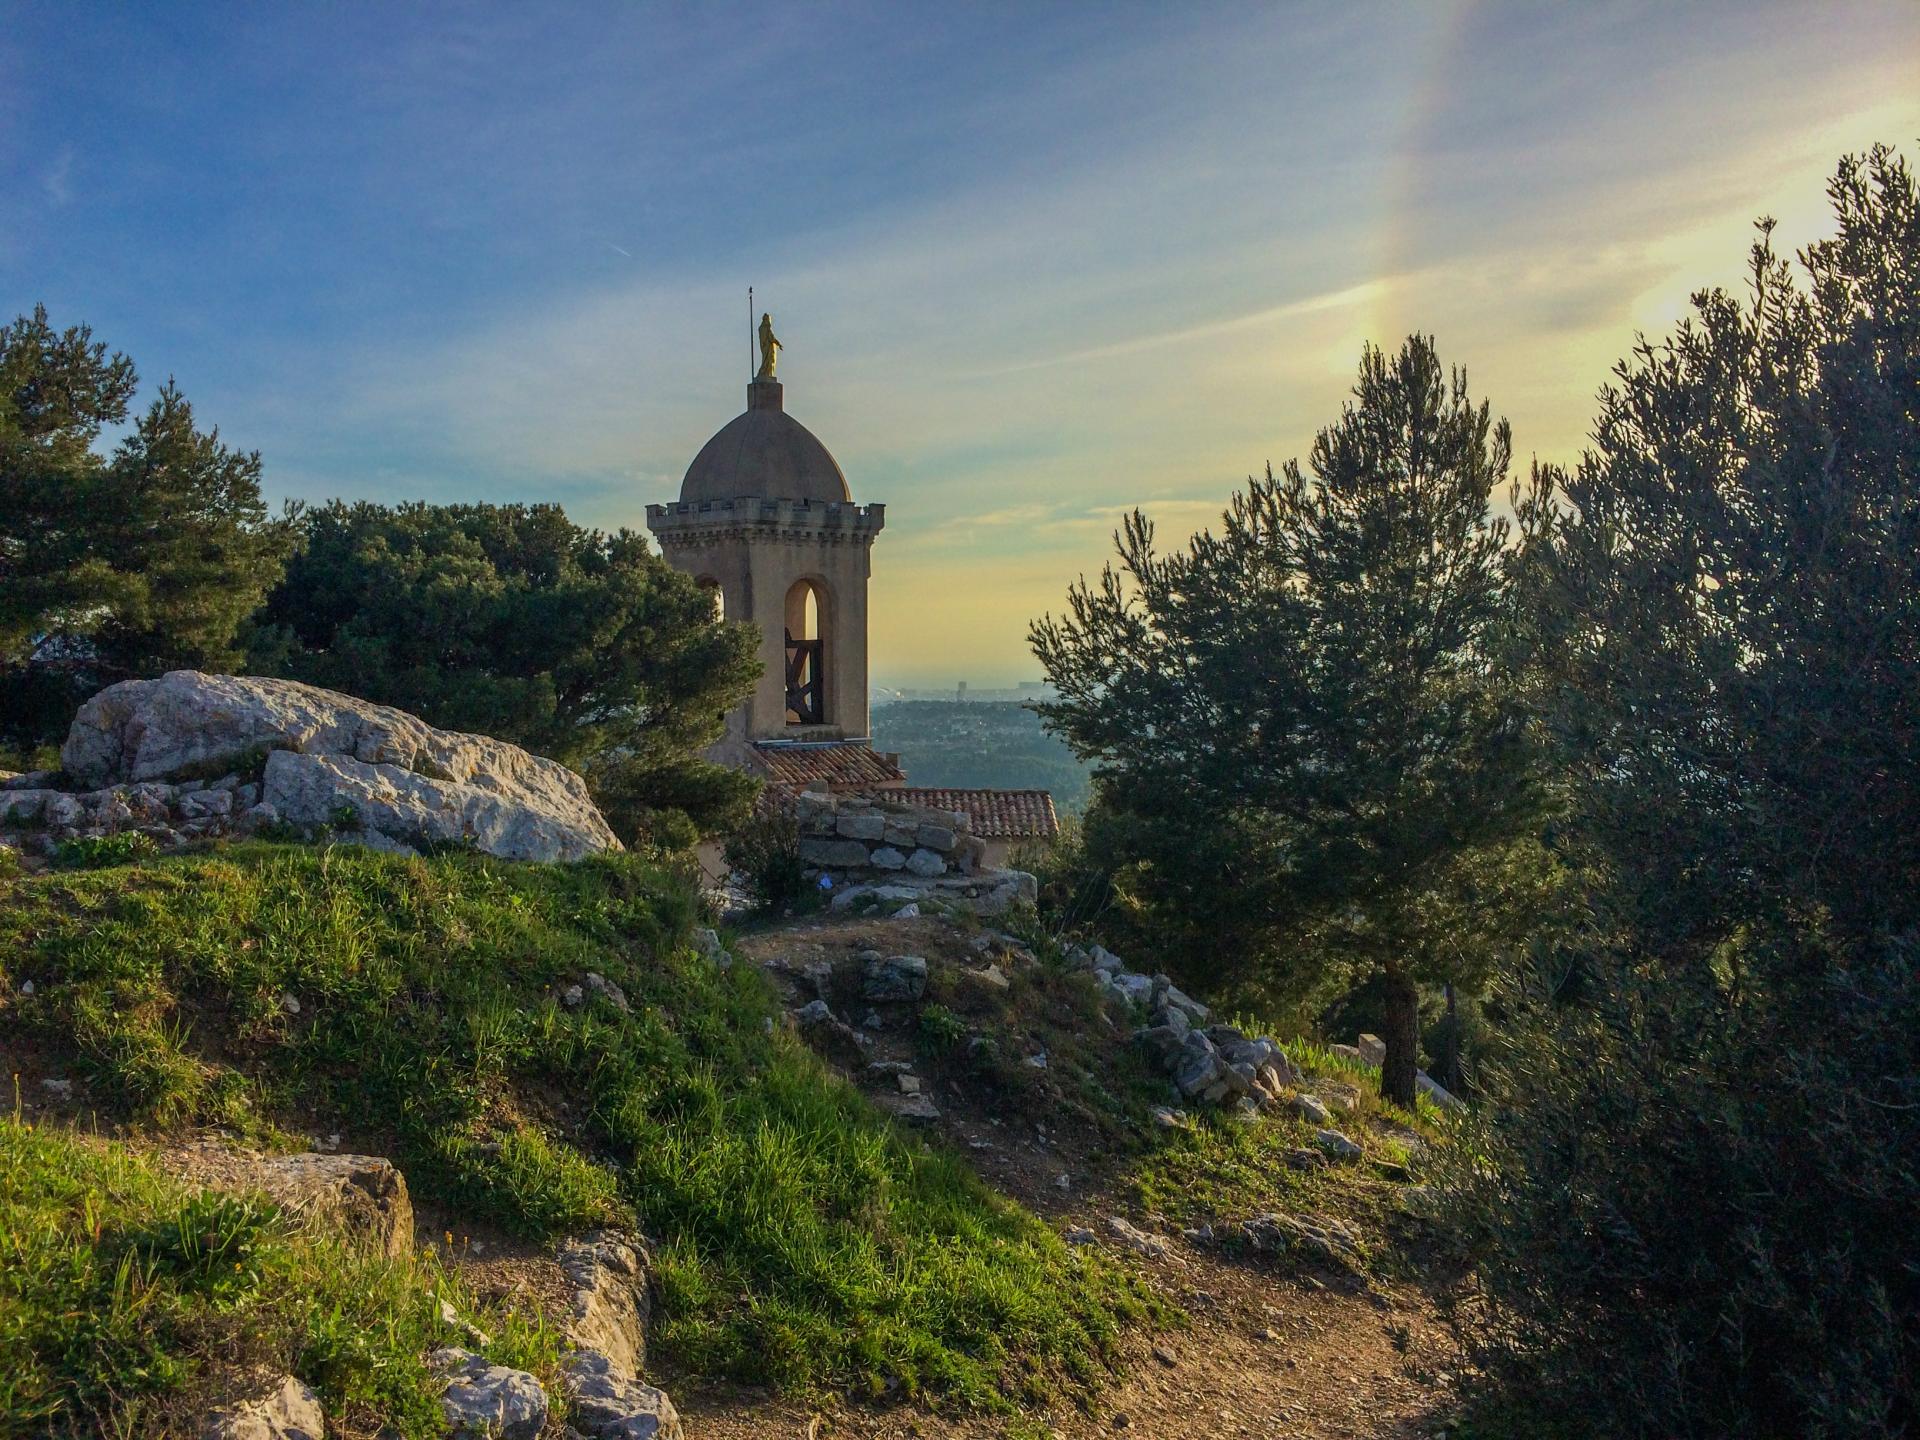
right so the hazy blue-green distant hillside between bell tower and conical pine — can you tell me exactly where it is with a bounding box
[874,701,1089,814]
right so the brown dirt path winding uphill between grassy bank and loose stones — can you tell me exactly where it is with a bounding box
[683,918,1455,1440]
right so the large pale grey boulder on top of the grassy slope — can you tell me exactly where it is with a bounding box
[26,670,620,860]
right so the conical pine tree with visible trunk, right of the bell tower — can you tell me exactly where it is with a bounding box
[1031,336,1549,1102]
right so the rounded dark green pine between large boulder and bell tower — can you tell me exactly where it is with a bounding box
[250,501,758,841]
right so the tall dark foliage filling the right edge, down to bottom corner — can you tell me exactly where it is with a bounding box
[1450,150,1920,1436]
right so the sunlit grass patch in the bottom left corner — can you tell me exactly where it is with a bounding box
[0,1116,557,1436]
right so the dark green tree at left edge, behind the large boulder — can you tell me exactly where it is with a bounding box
[0,307,292,741]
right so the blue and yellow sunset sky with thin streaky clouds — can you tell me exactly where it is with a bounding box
[0,0,1920,685]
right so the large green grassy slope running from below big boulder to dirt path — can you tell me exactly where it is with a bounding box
[0,843,1140,1405]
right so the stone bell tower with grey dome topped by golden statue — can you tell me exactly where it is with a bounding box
[647,339,885,768]
